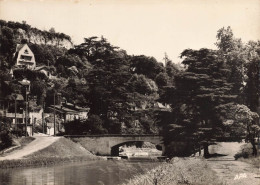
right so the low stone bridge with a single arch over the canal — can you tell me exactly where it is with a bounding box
[64,135,164,156]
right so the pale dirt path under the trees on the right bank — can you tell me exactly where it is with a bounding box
[207,142,260,185]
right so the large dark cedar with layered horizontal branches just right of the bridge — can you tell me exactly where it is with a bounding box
[159,49,236,157]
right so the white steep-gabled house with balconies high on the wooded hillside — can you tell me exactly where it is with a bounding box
[14,44,36,69]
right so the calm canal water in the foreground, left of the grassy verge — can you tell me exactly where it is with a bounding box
[0,160,159,185]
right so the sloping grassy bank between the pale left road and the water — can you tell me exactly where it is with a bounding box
[0,138,102,168]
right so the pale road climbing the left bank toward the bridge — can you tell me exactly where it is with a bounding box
[0,135,59,160]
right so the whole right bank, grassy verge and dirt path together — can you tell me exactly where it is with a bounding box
[124,142,260,185]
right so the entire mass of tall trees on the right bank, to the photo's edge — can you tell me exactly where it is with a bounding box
[158,27,260,157]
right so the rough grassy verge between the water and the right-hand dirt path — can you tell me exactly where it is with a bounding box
[123,158,224,185]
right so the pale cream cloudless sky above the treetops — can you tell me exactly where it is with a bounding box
[0,0,260,62]
